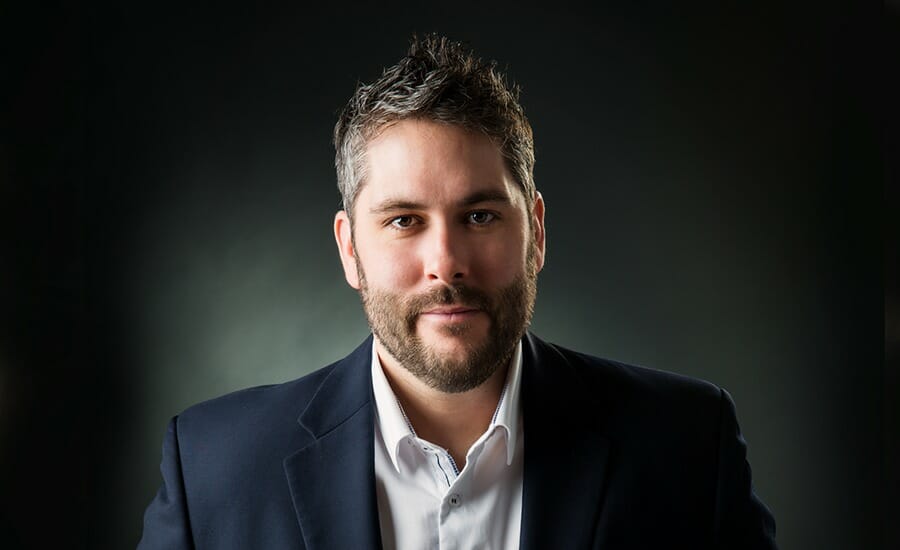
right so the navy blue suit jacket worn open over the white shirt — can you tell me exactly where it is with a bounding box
[139,334,775,550]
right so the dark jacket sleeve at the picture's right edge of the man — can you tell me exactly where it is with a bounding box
[715,390,777,550]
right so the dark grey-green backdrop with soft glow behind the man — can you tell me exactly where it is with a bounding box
[0,1,898,549]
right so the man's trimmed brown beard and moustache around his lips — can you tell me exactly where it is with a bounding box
[356,248,537,393]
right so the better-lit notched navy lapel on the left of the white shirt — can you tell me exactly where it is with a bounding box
[284,337,381,550]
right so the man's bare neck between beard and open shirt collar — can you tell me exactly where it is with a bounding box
[375,338,509,469]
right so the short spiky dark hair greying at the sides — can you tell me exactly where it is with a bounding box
[334,34,535,217]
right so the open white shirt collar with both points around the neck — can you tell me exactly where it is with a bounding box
[371,341,522,472]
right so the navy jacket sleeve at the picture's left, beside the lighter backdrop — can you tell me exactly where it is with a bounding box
[138,416,194,550]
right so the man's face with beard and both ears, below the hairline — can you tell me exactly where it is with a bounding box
[335,119,544,393]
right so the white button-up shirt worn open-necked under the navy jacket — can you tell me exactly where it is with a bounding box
[372,342,523,550]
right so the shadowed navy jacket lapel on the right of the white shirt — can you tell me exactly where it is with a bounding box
[520,334,609,550]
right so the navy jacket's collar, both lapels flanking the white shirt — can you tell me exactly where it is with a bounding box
[284,333,609,550]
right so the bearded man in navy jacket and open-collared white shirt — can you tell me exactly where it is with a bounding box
[140,36,775,549]
